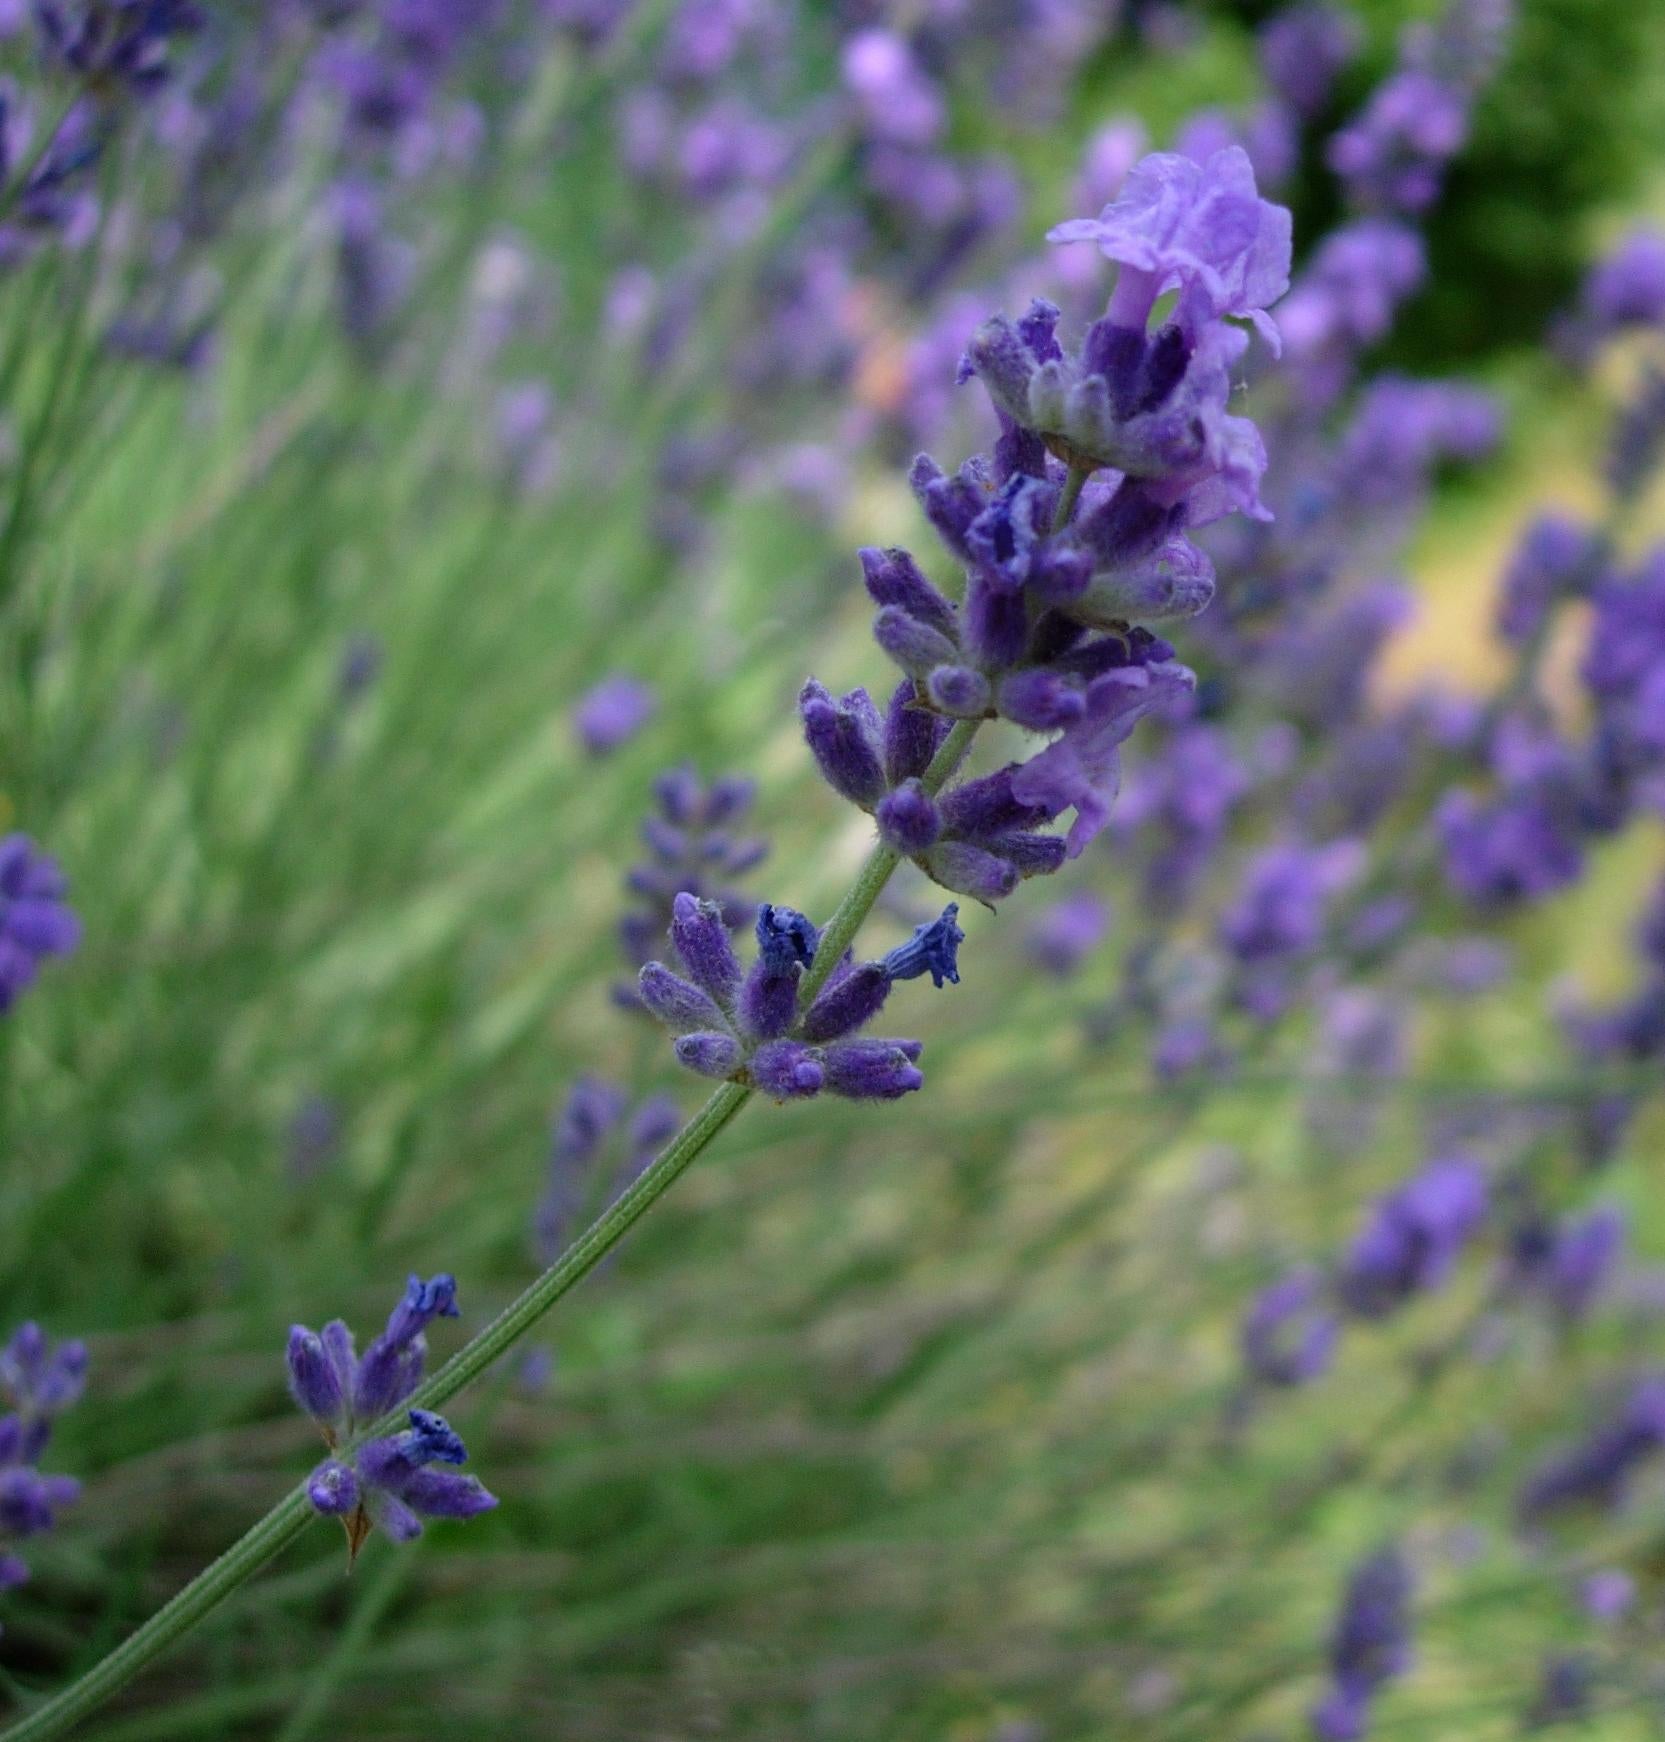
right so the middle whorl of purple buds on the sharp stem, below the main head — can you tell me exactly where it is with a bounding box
[639,894,965,1101]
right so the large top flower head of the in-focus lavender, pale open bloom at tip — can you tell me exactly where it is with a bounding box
[799,150,1289,902]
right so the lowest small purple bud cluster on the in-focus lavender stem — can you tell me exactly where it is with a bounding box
[287,1275,496,1556]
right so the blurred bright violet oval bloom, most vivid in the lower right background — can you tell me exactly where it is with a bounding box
[1338,1157,1487,1319]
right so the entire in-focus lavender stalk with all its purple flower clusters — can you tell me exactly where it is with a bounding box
[0,148,1289,1737]
